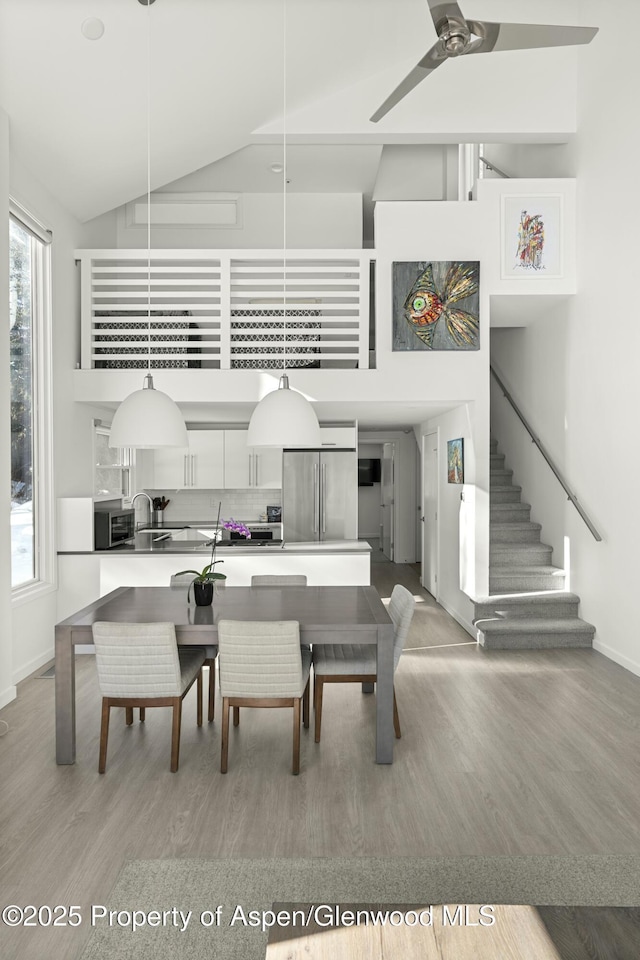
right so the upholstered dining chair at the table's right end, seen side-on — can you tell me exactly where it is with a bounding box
[313,583,415,743]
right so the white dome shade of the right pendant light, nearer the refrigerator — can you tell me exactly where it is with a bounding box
[247,374,320,447]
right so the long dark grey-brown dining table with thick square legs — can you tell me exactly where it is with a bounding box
[55,584,394,764]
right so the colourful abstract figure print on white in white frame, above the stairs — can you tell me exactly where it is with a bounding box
[501,194,563,280]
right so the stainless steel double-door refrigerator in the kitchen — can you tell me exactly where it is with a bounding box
[282,450,358,543]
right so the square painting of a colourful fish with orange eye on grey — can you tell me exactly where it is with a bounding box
[394,261,479,350]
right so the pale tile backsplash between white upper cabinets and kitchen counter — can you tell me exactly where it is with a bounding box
[141,489,282,522]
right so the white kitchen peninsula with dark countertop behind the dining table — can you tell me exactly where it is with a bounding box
[58,530,371,620]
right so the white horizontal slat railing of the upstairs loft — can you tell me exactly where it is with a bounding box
[76,250,372,369]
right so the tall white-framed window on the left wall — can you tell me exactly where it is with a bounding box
[9,204,52,591]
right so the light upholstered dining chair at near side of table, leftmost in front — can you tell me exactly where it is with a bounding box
[93,621,204,773]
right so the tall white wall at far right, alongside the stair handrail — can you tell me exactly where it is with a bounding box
[492,0,640,674]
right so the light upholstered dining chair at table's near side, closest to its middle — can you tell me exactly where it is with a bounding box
[218,620,311,774]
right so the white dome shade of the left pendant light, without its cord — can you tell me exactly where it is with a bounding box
[109,374,189,448]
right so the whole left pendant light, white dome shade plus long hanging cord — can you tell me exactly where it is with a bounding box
[109,0,189,448]
